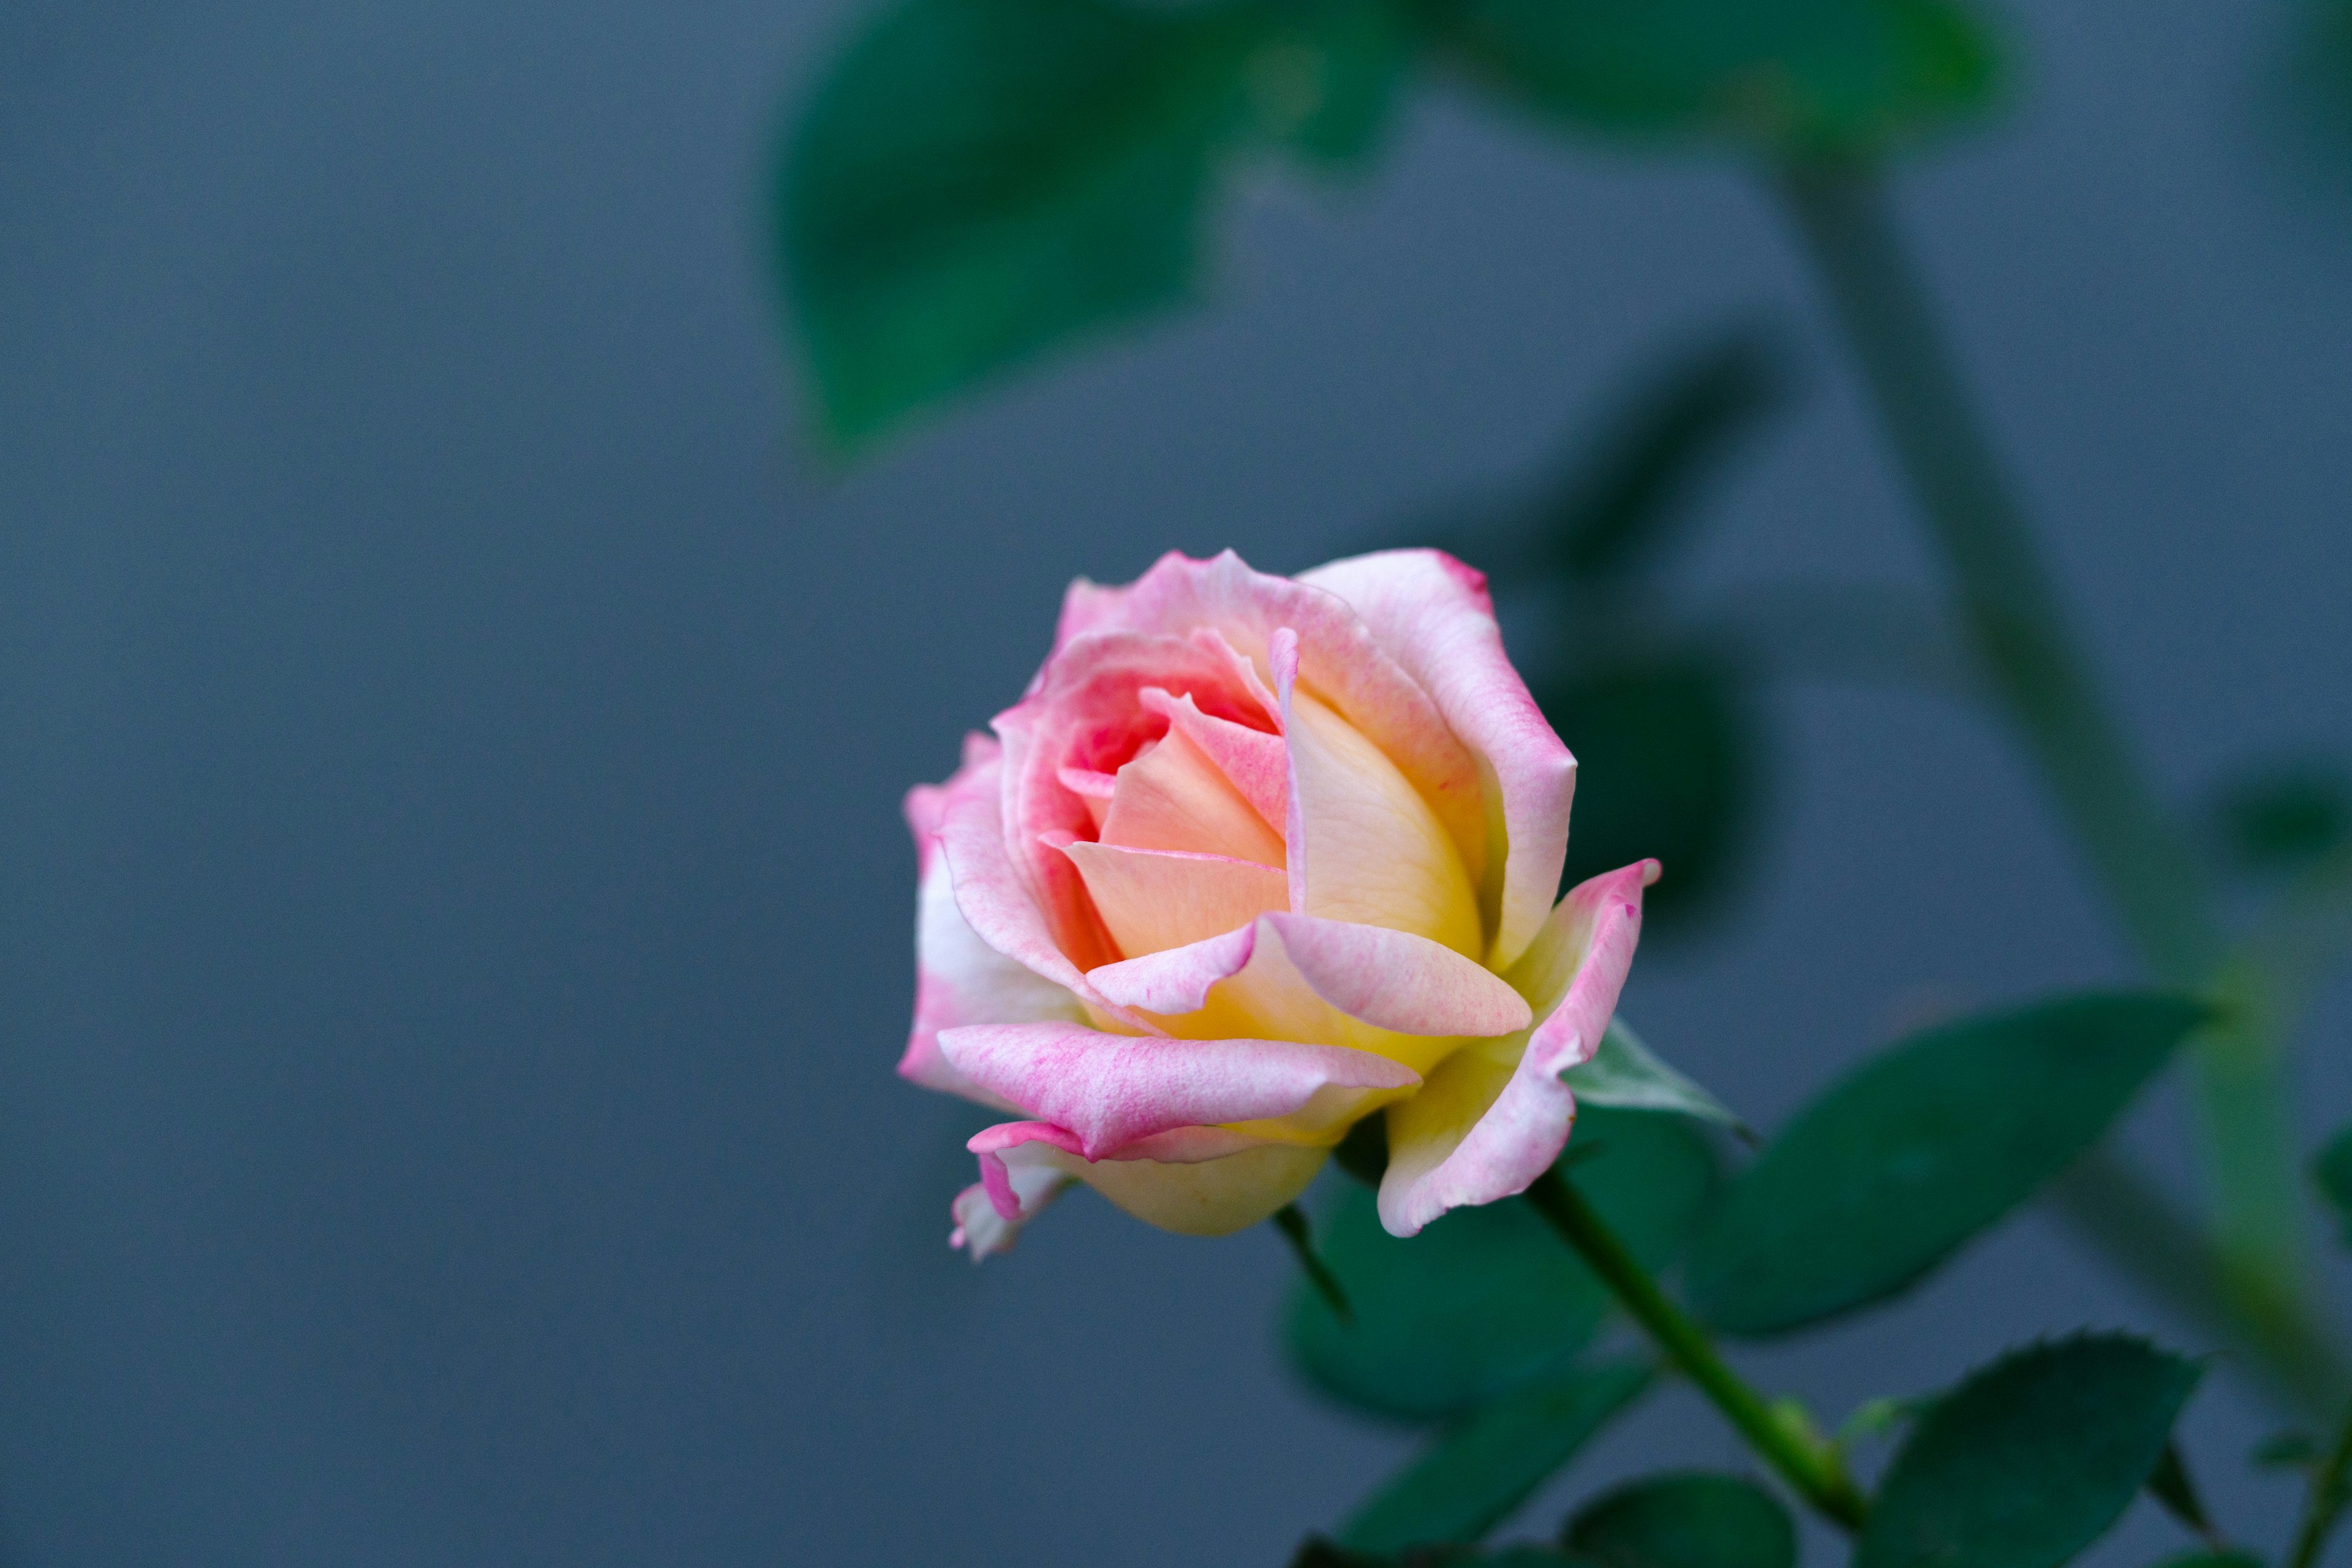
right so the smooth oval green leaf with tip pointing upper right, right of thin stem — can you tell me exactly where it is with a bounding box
[1689,995,2206,1335]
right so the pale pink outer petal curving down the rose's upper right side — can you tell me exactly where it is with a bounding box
[1298,550,1576,968]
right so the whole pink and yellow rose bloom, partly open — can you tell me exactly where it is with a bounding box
[899,550,1658,1257]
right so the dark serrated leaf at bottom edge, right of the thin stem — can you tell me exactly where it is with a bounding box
[1853,1333,2201,1568]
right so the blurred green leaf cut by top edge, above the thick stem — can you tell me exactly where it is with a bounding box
[1439,0,1997,155]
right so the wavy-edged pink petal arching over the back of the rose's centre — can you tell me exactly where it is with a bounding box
[1049,550,1477,893]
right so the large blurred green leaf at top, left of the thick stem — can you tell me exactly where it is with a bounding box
[778,0,1406,447]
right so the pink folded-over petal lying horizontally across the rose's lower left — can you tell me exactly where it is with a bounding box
[938,1023,1420,1159]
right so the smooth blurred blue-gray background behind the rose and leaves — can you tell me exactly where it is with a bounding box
[0,0,2352,1568]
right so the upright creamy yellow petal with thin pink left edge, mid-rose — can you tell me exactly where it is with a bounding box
[1272,630,1487,957]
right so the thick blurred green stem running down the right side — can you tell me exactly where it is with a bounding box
[1781,165,2310,1373]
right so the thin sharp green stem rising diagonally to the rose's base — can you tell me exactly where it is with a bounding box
[1526,1169,1870,1531]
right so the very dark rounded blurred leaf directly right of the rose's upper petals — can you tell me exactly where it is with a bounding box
[1536,654,1762,933]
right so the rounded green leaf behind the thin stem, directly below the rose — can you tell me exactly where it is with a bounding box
[1284,1110,1714,1422]
